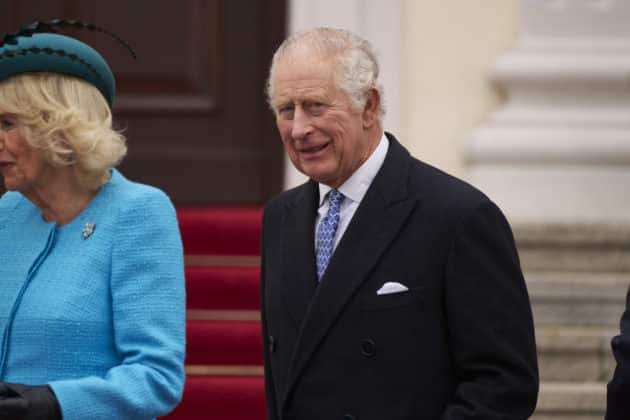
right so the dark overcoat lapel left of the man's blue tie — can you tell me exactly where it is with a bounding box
[280,181,319,328]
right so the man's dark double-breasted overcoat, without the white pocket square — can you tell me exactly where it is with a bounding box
[261,134,538,420]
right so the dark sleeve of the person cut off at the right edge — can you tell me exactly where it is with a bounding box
[606,290,630,420]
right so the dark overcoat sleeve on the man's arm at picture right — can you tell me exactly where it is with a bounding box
[442,201,538,420]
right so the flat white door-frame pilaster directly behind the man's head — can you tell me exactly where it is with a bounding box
[285,0,402,188]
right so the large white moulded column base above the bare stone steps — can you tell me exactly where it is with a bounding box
[467,0,630,225]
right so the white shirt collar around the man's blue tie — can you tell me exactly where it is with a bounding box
[319,132,389,207]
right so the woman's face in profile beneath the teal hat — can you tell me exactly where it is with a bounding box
[0,115,50,193]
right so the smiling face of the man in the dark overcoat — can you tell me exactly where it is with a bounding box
[271,51,378,188]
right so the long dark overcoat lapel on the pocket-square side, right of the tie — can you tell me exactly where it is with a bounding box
[284,136,415,401]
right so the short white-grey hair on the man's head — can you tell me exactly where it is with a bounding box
[267,28,385,121]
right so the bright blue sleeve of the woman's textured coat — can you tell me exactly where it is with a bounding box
[50,189,185,420]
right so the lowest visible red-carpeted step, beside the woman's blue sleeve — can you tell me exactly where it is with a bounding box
[160,376,265,420]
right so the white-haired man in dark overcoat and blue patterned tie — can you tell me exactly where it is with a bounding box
[261,28,538,420]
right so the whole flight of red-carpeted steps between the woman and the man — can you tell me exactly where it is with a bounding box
[161,207,266,420]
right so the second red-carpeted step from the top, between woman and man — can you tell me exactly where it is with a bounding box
[186,266,260,310]
